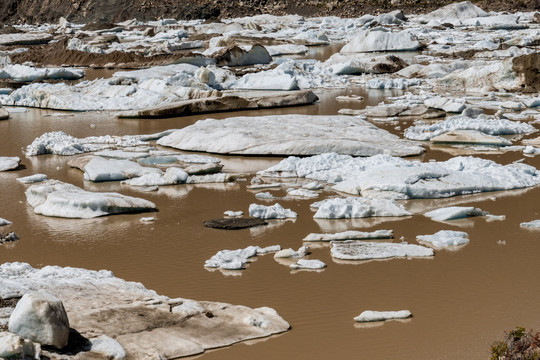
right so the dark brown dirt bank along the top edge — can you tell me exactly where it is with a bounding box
[0,0,540,23]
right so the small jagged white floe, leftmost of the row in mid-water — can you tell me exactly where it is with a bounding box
[204,245,281,270]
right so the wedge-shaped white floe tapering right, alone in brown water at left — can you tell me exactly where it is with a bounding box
[25,180,156,218]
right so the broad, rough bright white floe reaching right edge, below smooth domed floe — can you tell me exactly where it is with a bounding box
[258,153,540,199]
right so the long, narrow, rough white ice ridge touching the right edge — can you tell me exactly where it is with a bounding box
[404,115,537,140]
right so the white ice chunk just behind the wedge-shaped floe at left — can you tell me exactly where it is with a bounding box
[83,157,162,182]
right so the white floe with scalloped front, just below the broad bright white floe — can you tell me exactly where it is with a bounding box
[311,197,412,219]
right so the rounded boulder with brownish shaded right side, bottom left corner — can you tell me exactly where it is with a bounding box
[9,291,69,349]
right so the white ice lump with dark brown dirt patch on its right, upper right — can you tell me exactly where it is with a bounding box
[323,53,407,75]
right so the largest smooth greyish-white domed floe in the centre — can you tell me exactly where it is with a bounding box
[157,114,424,156]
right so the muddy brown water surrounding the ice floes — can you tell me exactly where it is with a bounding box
[0,89,540,360]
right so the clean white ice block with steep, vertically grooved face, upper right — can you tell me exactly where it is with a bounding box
[340,31,421,53]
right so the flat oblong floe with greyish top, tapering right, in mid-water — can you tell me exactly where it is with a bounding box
[331,240,434,260]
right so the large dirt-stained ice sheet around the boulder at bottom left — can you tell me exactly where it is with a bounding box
[0,263,290,359]
